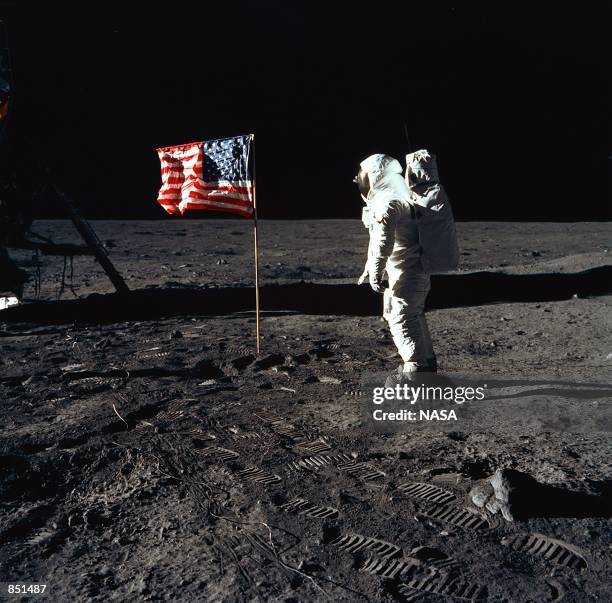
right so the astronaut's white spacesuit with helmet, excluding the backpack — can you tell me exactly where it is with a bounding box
[359,154,437,373]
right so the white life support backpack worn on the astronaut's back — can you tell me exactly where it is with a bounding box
[404,149,459,273]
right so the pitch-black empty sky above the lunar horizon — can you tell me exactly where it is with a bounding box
[2,1,612,221]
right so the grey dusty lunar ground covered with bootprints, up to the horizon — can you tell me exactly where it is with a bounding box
[0,220,612,603]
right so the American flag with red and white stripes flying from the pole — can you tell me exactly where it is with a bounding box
[157,134,253,218]
